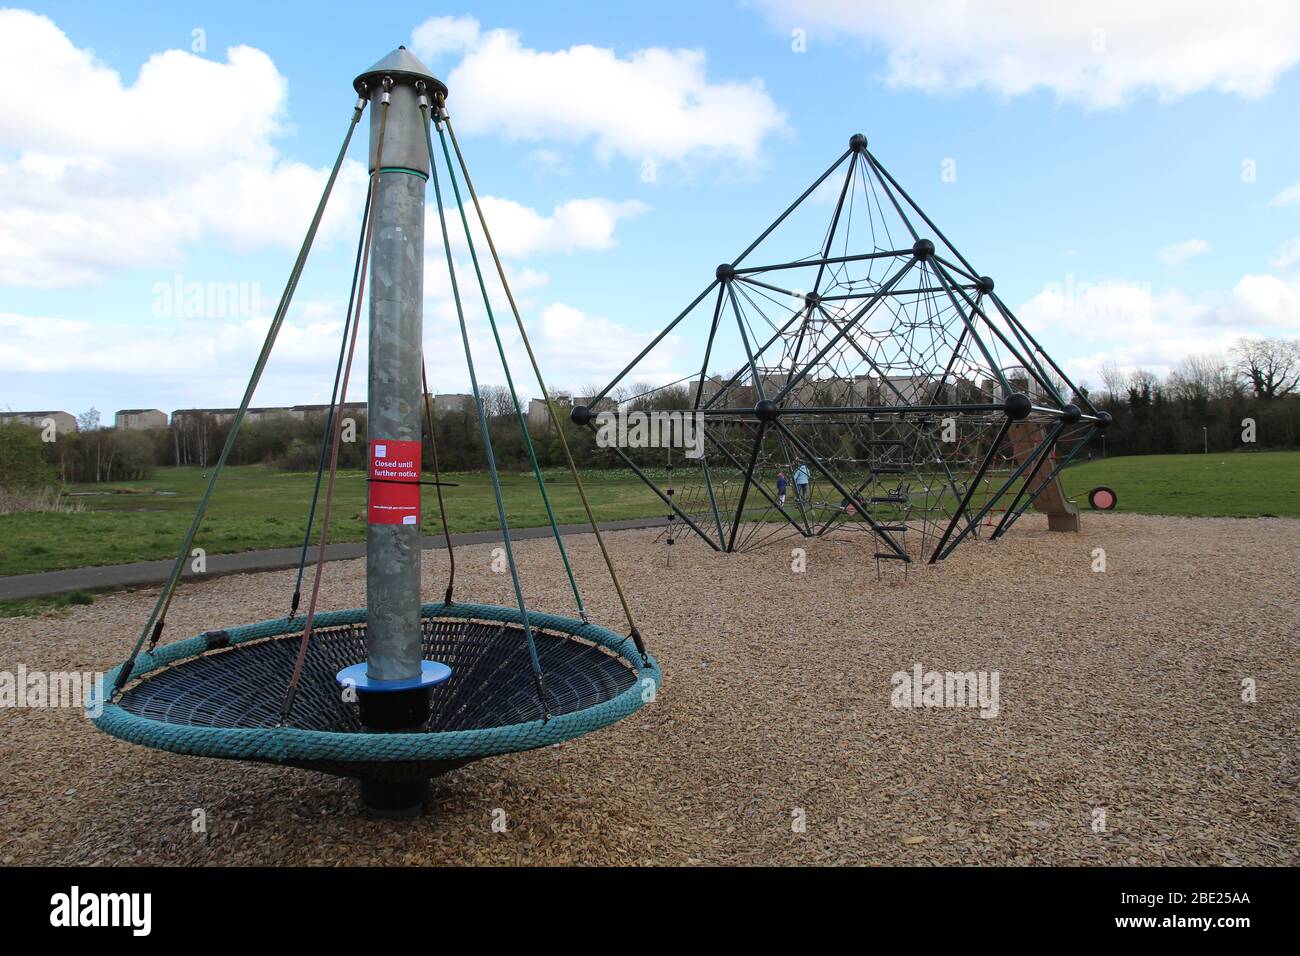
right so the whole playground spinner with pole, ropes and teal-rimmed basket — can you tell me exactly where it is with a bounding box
[87,48,659,817]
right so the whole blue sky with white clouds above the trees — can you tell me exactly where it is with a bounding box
[0,0,1300,418]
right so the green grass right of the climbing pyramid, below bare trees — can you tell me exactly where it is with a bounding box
[1062,451,1300,518]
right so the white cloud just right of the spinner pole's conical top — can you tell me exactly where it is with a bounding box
[411,17,785,163]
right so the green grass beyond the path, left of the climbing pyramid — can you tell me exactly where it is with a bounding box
[0,464,664,575]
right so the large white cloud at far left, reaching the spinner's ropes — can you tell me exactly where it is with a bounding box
[0,9,365,287]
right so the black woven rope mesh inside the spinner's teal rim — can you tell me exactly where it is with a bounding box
[120,619,636,734]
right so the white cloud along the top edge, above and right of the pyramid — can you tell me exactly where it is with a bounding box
[754,0,1300,108]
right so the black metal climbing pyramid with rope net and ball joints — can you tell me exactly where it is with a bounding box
[573,134,1109,562]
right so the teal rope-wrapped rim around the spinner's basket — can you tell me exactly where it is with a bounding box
[86,602,660,763]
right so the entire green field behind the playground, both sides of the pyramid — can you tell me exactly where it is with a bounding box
[0,451,1300,575]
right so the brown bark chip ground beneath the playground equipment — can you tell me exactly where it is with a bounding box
[0,514,1300,865]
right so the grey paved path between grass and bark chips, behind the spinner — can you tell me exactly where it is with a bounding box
[0,518,668,601]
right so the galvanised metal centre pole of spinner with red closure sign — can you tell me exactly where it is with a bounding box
[354,47,446,817]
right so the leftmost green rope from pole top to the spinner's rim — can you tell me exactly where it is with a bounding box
[113,101,365,693]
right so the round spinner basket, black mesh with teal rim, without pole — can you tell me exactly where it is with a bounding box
[90,604,659,779]
